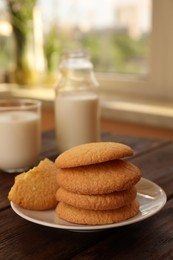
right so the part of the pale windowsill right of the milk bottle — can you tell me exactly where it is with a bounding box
[102,100,173,129]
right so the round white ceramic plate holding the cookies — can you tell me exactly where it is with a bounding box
[11,178,167,232]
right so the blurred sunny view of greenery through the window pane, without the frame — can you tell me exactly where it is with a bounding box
[0,0,151,85]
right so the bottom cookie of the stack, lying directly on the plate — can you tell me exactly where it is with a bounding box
[56,200,139,225]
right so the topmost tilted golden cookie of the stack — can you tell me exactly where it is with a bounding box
[55,142,133,168]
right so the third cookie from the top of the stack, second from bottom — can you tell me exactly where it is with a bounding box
[56,186,137,210]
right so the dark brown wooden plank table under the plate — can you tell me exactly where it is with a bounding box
[0,131,173,260]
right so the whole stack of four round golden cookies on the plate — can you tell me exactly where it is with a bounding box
[55,142,141,225]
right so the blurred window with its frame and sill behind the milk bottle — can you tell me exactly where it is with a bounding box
[0,0,173,128]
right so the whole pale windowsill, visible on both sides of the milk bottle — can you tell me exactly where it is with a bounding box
[0,84,173,129]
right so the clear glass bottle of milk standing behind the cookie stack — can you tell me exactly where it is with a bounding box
[55,50,100,153]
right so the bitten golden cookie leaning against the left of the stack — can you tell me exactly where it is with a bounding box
[8,159,58,210]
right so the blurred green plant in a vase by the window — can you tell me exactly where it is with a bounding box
[8,0,45,86]
